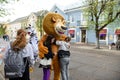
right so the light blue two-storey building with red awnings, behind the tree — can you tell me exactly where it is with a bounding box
[51,2,120,45]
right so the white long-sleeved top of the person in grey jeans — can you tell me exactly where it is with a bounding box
[56,41,70,51]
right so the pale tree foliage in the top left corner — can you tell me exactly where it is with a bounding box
[0,0,19,17]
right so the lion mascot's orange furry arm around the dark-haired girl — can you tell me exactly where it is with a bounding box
[38,35,48,58]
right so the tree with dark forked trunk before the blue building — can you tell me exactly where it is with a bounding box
[84,0,120,49]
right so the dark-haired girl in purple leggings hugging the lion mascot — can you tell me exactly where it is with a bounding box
[39,35,53,80]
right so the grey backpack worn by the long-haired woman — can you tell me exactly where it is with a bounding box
[4,42,27,78]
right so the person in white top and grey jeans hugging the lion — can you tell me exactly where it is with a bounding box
[56,37,71,80]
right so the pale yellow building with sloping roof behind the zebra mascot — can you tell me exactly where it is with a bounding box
[6,10,48,39]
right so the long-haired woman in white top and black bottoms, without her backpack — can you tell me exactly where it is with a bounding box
[5,29,34,80]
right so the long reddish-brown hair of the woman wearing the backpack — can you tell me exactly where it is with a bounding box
[11,29,27,51]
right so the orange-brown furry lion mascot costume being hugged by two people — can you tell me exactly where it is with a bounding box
[38,12,67,80]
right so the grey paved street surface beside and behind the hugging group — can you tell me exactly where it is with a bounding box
[31,45,120,80]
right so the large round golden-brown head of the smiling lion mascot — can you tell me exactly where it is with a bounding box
[43,13,67,38]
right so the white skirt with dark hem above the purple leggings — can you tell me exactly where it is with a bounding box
[39,57,52,68]
